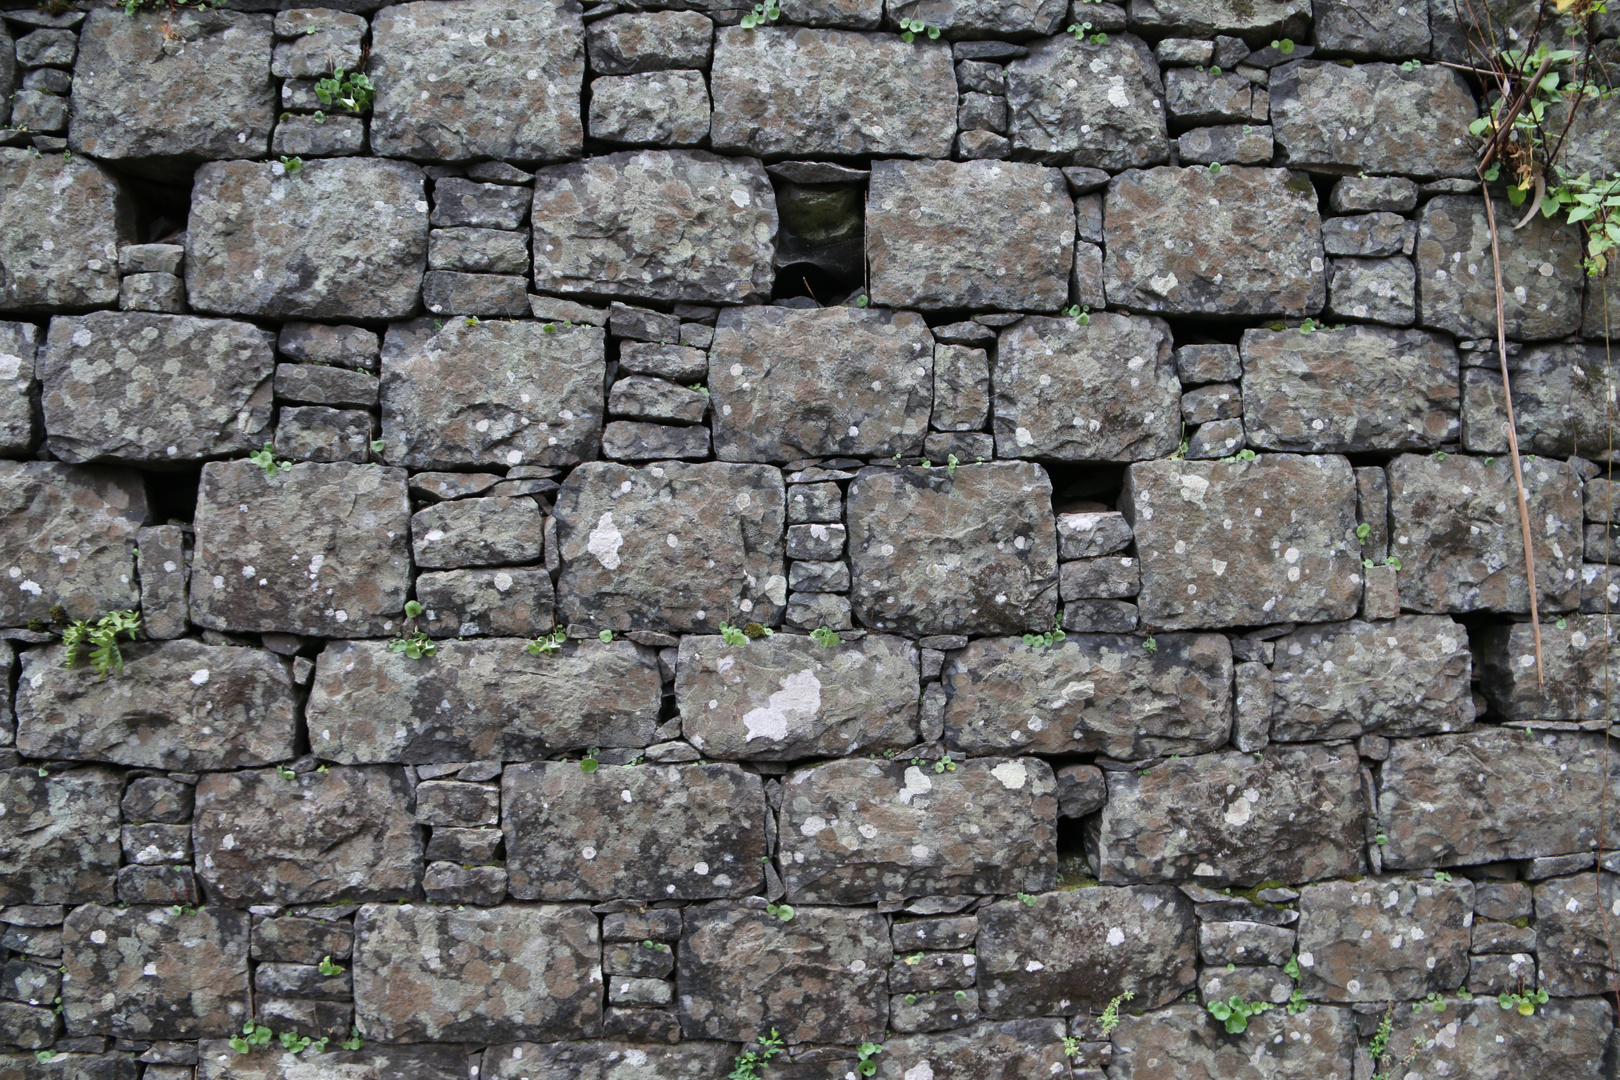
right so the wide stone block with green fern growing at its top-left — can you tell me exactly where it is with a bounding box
[16,641,298,771]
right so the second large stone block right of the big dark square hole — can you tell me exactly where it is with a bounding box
[1103,165,1327,316]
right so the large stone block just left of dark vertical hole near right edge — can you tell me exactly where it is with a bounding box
[1270,615,1474,742]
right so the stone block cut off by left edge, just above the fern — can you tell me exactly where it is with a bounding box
[0,461,147,627]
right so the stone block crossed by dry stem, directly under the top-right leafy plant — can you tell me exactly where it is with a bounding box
[1416,194,1581,342]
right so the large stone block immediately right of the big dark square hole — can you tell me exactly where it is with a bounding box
[867,160,1074,311]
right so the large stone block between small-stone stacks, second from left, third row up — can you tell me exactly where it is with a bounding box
[191,766,421,904]
